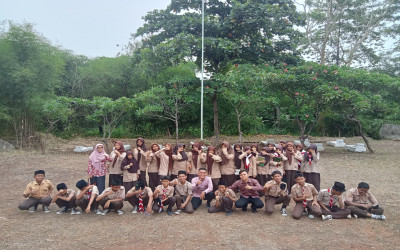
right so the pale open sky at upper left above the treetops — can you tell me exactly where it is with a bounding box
[0,0,170,57]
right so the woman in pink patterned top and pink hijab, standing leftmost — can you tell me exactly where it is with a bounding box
[87,144,113,192]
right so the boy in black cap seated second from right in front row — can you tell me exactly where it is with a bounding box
[317,181,351,220]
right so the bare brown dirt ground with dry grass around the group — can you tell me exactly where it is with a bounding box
[0,135,400,249]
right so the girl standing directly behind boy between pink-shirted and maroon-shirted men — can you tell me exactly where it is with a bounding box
[218,141,236,186]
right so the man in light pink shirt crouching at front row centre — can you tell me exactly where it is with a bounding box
[192,168,214,210]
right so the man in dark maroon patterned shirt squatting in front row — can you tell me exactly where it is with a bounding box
[229,170,264,213]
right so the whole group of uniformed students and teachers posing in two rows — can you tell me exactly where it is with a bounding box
[19,138,386,220]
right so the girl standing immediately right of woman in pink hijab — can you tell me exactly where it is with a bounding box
[108,141,126,187]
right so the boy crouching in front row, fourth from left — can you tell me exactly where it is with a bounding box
[96,178,125,215]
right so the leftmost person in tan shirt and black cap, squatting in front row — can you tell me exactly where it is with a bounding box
[18,170,54,213]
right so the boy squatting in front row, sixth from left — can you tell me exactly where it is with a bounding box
[153,176,176,215]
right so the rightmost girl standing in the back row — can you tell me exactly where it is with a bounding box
[301,144,321,191]
